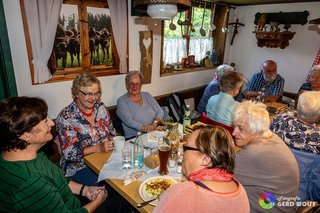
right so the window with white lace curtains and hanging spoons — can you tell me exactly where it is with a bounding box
[160,2,227,74]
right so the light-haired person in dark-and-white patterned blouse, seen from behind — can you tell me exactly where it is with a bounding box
[270,91,320,154]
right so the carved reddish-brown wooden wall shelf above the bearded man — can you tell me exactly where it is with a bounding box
[253,31,295,49]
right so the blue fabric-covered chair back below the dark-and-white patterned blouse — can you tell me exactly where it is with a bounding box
[290,148,320,202]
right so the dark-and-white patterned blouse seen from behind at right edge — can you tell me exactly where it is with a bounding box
[270,113,320,154]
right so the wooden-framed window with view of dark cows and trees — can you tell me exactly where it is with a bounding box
[22,0,125,82]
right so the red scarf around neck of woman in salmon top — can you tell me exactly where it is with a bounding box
[188,168,234,182]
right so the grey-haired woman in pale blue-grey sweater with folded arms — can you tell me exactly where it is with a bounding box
[117,71,164,138]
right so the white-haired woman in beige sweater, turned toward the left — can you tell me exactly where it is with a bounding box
[232,101,299,212]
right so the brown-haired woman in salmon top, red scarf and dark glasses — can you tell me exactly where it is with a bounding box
[154,126,250,213]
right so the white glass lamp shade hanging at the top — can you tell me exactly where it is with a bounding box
[147,4,178,20]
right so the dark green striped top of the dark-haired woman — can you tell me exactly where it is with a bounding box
[0,152,87,213]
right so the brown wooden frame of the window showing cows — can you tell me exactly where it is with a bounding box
[20,0,128,85]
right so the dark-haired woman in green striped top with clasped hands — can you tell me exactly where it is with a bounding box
[0,97,107,212]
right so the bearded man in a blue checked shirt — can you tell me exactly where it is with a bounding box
[245,60,284,101]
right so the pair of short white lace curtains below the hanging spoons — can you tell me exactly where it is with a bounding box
[163,38,213,64]
